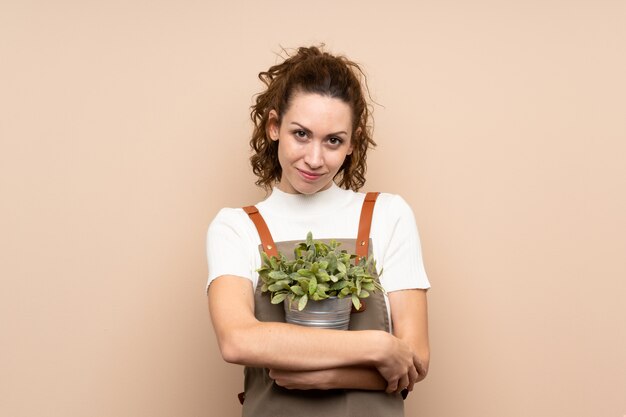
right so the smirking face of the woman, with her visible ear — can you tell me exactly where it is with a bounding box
[268,93,352,194]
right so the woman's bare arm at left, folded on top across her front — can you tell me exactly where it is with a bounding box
[209,276,419,391]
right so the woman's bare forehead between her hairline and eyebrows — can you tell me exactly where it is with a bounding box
[283,92,352,131]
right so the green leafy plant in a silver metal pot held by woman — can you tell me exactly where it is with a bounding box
[258,232,384,329]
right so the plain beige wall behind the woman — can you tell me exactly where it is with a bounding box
[0,0,626,417]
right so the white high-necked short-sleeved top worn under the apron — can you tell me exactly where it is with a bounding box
[207,183,430,292]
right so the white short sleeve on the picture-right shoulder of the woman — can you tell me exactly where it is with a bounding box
[380,195,430,292]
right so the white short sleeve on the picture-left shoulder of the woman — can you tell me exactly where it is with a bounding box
[206,208,256,291]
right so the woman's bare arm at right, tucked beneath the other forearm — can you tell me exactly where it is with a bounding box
[270,290,430,392]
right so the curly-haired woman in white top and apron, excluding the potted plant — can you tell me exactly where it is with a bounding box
[207,47,429,417]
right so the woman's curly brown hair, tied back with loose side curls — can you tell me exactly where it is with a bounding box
[250,45,376,191]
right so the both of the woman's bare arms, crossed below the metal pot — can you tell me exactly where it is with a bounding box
[209,276,429,392]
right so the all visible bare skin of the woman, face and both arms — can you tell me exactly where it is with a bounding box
[209,93,430,393]
